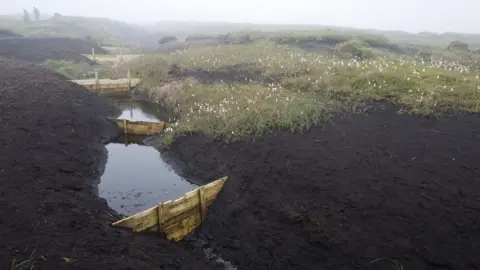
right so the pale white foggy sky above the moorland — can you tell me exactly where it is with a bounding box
[0,0,480,33]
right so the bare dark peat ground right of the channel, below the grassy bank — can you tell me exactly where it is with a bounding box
[164,103,480,270]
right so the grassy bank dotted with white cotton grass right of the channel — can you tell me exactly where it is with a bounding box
[121,43,480,143]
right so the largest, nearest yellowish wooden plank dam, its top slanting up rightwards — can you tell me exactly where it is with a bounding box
[112,176,228,241]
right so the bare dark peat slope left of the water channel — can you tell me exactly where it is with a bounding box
[0,59,211,269]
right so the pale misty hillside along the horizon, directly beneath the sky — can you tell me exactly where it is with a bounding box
[0,14,480,49]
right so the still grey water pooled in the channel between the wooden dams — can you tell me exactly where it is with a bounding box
[98,98,197,215]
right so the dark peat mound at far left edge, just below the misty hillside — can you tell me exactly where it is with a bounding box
[0,37,108,64]
